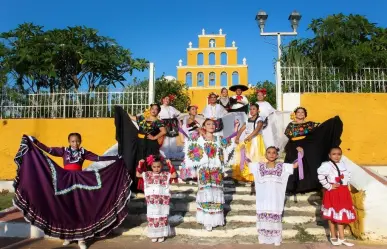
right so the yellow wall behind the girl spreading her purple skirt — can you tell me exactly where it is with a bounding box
[0,118,116,180]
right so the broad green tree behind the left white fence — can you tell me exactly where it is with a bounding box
[0,23,148,92]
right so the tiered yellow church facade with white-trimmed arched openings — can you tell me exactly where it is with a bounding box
[177,29,248,112]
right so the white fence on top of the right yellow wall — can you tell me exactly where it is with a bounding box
[281,67,387,93]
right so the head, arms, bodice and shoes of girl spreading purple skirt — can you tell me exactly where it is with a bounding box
[29,133,118,249]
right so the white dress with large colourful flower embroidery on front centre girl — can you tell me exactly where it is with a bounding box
[184,135,230,227]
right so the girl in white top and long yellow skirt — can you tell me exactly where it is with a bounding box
[232,104,265,187]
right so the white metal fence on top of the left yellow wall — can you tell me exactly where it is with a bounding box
[0,86,150,119]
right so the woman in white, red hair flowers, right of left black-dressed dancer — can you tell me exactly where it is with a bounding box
[159,95,184,159]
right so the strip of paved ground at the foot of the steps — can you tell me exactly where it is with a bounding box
[0,236,386,249]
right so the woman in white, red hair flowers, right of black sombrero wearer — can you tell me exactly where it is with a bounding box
[257,88,278,148]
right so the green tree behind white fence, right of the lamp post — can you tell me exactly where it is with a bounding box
[282,13,387,73]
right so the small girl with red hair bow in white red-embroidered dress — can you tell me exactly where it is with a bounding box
[136,155,177,242]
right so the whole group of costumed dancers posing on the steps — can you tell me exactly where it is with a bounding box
[14,85,356,249]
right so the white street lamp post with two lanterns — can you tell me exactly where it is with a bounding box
[255,10,301,111]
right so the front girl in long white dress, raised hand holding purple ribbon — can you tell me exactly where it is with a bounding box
[249,146,303,246]
